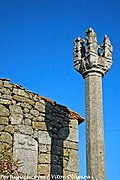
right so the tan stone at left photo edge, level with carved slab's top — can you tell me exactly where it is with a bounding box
[0,132,12,144]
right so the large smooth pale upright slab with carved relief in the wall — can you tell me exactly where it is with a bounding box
[13,133,38,176]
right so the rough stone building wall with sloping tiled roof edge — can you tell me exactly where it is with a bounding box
[0,78,83,180]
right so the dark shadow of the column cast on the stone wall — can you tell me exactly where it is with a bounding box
[45,103,69,180]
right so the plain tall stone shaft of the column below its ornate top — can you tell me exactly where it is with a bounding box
[85,72,105,180]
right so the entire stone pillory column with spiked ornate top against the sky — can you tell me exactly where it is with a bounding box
[74,28,112,180]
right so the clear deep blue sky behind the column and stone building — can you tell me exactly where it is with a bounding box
[0,0,120,180]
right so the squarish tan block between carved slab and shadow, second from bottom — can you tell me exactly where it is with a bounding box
[38,153,51,164]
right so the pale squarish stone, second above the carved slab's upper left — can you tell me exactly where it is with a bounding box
[10,114,23,124]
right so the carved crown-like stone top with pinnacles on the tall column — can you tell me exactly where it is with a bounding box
[74,28,113,78]
